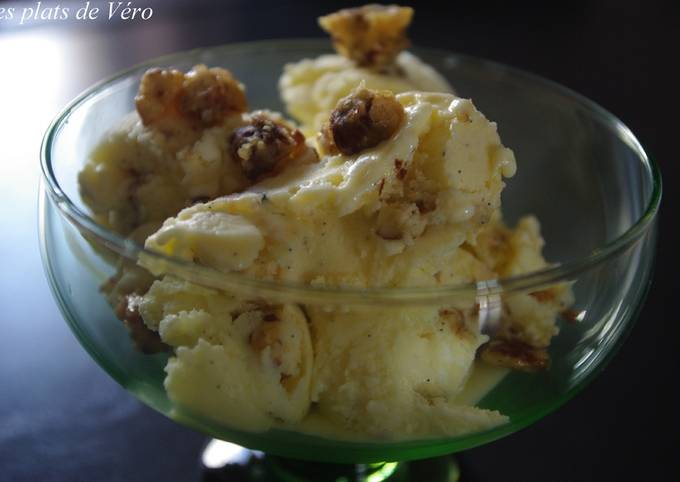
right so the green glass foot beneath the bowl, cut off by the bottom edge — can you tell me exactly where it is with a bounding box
[201,440,460,482]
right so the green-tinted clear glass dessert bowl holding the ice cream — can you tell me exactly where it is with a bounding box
[40,41,661,480]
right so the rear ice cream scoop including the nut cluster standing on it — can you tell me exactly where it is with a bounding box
[279,5,453,137]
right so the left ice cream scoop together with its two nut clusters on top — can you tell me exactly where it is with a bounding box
[78,65,316,235]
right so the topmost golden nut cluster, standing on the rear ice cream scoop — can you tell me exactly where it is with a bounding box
[319,4,413,70]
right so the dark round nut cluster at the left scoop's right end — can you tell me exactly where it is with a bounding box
[231,112,307,180]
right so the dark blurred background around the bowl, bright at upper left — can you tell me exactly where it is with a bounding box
[0,0,680,481]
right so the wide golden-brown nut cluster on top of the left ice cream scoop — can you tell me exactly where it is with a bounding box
[135,65,247,128]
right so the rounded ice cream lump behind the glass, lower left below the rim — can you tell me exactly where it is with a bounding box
[139,277,313,431]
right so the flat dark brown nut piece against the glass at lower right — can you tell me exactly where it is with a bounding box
[480,339,550,372]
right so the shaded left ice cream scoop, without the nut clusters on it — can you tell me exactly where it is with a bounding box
[78,111,315,234]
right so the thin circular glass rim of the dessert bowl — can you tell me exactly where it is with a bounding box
[40,39,662,304]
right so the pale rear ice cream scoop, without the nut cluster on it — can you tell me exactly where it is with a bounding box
[279,52,453,137]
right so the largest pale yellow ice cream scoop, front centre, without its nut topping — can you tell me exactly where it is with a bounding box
[135,93,542,439]
